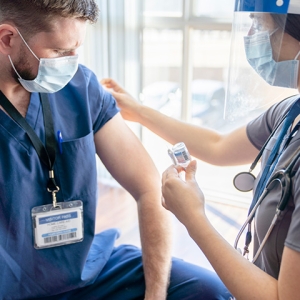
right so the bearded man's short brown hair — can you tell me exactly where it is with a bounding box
[0,0,99,38]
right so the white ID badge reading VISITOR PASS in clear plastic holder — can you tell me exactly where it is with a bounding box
[31,200,84,249]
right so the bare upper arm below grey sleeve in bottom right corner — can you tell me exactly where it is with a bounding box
[278,247,300,300]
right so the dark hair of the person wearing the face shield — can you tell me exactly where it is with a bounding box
[271,14,300,41]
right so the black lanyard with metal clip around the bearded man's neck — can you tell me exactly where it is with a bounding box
[0,91,59,207]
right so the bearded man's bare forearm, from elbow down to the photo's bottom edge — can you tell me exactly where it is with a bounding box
[138,195,172,300]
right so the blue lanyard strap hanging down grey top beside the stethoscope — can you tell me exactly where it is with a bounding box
[243,98,300,255]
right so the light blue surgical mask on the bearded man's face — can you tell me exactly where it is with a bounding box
[8,29,78,93]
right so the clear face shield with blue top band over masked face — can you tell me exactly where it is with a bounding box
[224,0,300,120]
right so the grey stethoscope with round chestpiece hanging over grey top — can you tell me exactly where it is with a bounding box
[233,116,300,263]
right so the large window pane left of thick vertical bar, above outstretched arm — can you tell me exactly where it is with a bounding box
[140,28,182,118]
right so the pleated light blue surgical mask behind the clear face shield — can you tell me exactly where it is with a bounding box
[244,29,300,89]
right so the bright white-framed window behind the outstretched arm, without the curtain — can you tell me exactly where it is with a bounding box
[140,0,251,206]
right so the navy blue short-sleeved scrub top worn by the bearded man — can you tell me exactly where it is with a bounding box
[0,66,119,299]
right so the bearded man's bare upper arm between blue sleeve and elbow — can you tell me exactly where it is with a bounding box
[94,114,160,199]
